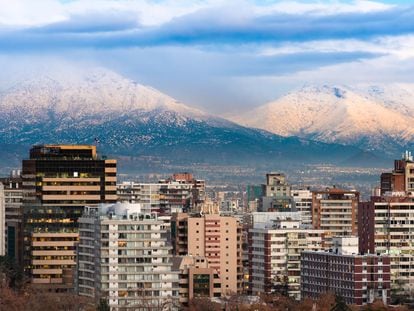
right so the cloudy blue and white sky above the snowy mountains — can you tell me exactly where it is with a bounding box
[0,0,414,115]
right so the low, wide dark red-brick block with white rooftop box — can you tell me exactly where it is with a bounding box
[301,236,390,306]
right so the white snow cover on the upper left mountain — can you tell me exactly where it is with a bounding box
[0,68,206,122]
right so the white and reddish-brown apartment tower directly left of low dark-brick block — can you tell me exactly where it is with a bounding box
[249,212,324,299]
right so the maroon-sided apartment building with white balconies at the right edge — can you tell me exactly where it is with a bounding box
[359,196,414,297]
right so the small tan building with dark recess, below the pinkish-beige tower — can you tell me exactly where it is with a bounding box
[173,256,221,306]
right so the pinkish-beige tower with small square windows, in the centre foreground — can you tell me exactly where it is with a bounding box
[171,213,243,295]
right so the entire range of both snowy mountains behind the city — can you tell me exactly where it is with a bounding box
[0,68,414,176]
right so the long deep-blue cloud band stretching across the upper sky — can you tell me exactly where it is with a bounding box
[0,4,414,50]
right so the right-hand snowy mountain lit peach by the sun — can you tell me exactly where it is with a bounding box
[231,84,414,154]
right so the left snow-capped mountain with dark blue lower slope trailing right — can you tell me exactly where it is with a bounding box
[0,69,360,171]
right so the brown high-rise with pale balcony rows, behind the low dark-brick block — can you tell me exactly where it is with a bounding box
[312,188,359,244]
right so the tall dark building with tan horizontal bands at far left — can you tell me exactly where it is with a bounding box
[22,145,117,290]
